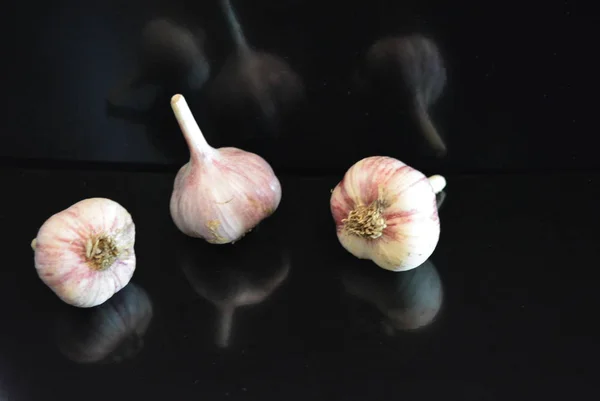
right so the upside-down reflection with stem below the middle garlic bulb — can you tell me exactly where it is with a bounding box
[181,231,290,348]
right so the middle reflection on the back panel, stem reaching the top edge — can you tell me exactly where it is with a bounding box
[210,0,304,136]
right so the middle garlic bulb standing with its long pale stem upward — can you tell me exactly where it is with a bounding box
[171,95,281,244]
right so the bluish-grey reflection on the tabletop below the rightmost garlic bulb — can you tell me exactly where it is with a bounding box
[342,261,443,334]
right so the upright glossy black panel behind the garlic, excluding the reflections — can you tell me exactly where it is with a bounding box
[0,0,599,174]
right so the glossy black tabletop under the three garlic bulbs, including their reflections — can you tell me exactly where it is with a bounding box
[0,169,600,401]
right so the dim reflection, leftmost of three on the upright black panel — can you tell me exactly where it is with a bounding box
[108,18,210,107]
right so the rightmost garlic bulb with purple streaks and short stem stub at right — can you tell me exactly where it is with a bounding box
[330,156,446,271]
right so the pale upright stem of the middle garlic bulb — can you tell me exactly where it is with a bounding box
[171,95,216,161]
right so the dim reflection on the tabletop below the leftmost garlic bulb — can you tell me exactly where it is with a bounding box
[57,283,153,363]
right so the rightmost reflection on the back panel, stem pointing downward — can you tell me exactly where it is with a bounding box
[363,34,447,156]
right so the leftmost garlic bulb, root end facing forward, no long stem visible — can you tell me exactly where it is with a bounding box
[31,198,136,308]
